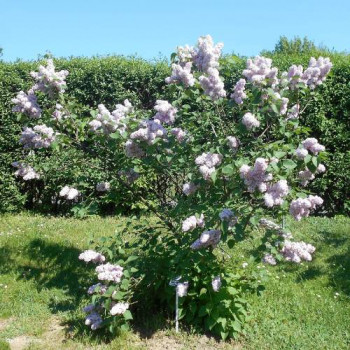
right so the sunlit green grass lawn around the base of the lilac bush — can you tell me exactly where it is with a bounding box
[0,214,350,350]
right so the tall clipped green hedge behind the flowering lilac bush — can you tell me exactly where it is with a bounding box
[0,50,350,214]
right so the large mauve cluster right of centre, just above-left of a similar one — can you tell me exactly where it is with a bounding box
[239,158,272,193]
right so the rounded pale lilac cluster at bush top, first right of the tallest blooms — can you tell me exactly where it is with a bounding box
[243,56,278,87]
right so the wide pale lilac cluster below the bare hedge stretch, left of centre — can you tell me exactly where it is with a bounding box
[89,100,133,135]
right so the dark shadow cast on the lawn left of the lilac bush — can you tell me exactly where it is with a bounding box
[0,239,93,313]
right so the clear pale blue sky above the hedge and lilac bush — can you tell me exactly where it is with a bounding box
[0,0,350,61]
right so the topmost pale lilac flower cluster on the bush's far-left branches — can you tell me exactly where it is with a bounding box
[30,59,69,97]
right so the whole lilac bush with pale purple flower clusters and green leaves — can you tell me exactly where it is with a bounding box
[13,36,332,338]
